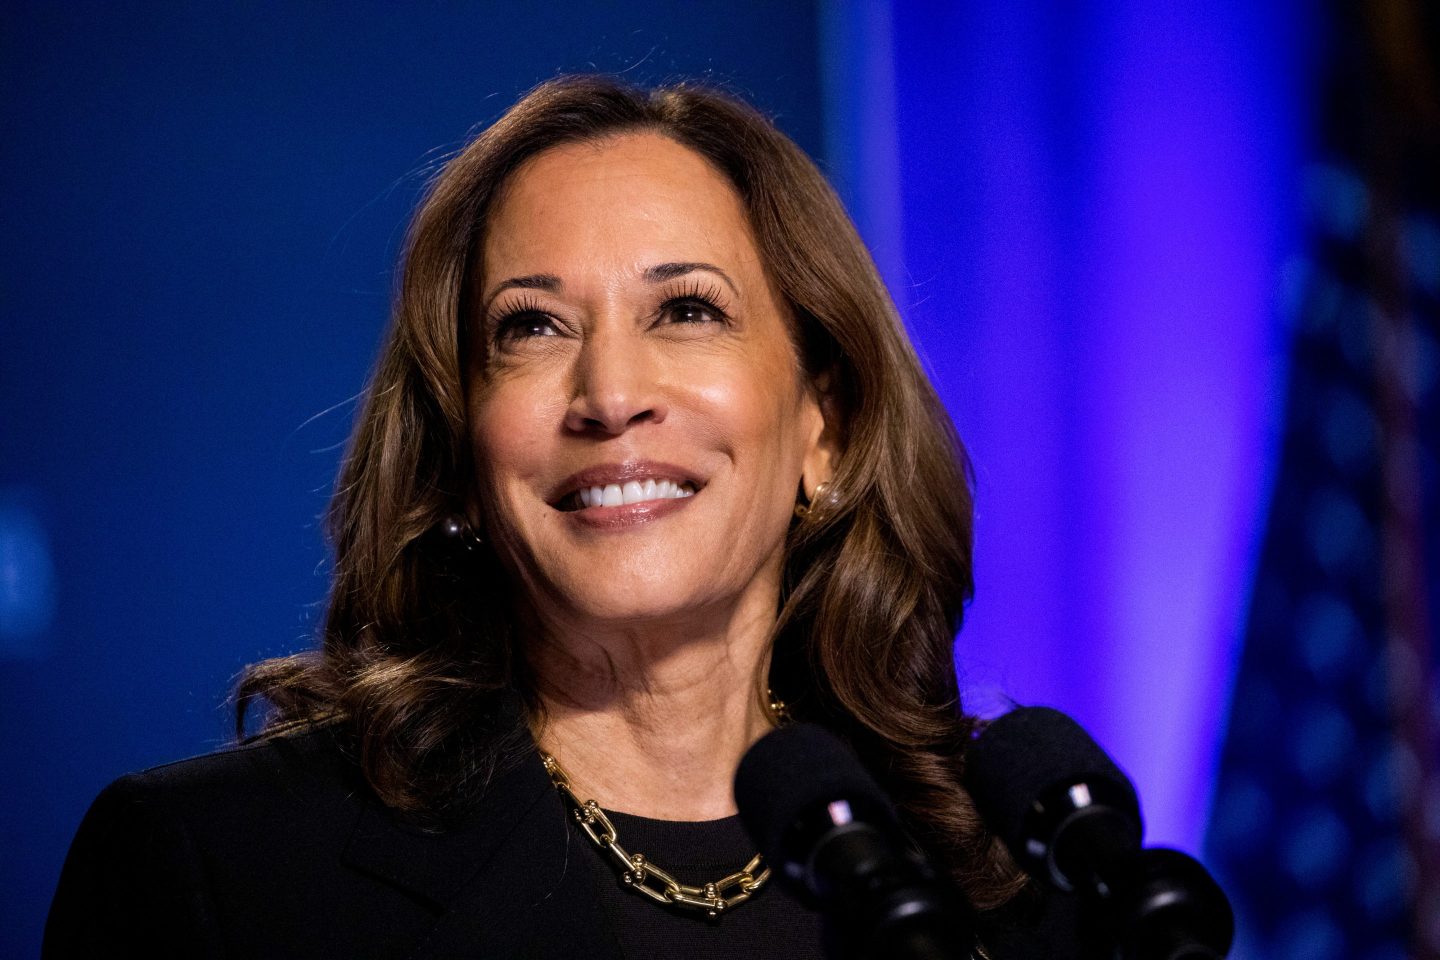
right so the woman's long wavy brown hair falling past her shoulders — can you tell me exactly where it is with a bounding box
[236,76,1020,908]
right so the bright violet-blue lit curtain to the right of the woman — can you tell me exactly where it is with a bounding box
[825,0,1306,849]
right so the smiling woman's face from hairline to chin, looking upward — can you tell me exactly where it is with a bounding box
[469,134,829,626]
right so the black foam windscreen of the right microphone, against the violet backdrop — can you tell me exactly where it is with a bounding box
[965,707,1139,853]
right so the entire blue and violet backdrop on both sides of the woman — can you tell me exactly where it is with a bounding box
[0,0,1347,956]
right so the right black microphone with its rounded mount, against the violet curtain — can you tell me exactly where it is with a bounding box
[965,707,1236,960]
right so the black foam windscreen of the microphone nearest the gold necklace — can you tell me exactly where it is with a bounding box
[734,724,896,862]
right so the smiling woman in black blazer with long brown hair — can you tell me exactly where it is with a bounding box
[46,78,1082,957]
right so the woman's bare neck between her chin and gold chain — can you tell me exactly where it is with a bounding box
[530,600,775,820]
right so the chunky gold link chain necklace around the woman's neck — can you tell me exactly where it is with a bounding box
[540,753,770,920]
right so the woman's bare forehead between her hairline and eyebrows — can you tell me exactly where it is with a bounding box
[484,132,759,276]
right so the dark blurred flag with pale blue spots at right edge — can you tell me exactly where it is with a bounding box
[1207,0,1440,960]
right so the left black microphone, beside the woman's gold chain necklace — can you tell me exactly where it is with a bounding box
[734,724,971,960]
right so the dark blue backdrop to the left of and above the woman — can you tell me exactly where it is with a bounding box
[0,0,821,956]
